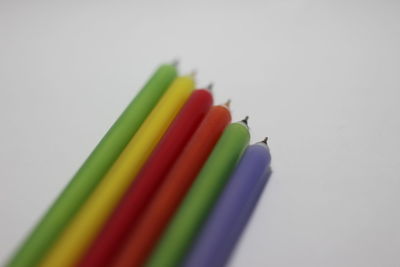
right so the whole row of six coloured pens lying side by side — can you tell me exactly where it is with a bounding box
[7,61,271,267]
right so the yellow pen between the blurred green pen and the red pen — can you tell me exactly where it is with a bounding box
[41,76,194,267]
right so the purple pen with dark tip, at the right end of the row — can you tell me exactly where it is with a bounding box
[184,140,271,267]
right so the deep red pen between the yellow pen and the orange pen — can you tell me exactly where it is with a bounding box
[80,90,212,266]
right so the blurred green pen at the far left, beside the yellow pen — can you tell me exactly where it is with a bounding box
[8,64,177,267]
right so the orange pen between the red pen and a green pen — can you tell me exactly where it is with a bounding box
[112,105,231,266]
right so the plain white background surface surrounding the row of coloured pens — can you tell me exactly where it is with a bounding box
[0,0,400,267]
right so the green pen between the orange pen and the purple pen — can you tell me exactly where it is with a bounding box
[147,122,250,267]
